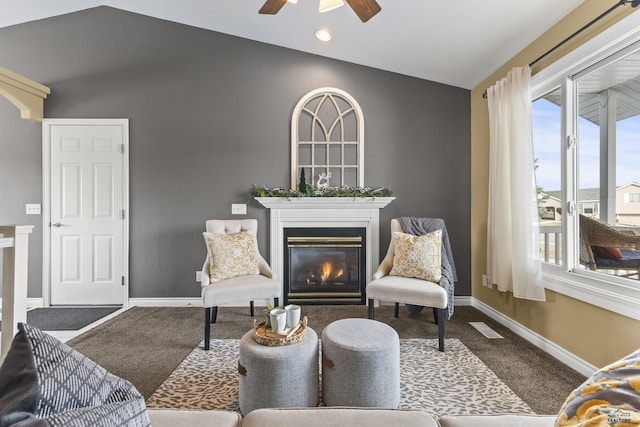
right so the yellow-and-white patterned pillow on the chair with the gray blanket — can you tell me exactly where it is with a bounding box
[389,230,442,283]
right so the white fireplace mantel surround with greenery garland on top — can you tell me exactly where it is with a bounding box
[255,197,395,290]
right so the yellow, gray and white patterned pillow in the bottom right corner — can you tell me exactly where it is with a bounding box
[556,349,640,427]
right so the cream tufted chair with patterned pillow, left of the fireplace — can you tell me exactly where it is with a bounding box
[201,219,282,350]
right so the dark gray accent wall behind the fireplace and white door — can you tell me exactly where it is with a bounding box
[0,7,471,298]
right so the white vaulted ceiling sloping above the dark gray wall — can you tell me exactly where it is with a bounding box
[0,0,592,89]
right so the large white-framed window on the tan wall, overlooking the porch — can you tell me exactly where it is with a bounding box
[532,14,640,320]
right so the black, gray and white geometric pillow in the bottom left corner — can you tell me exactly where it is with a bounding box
[0,323,150,427]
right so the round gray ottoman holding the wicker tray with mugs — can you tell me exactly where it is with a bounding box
[238,327,319,415]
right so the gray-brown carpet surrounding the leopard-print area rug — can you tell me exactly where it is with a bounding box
[69,306,585,414]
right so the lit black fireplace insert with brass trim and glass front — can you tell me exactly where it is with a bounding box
[283,227,366,304]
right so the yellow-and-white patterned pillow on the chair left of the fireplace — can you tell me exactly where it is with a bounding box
[202,231,260,282]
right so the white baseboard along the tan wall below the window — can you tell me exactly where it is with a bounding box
[471,298,598,377]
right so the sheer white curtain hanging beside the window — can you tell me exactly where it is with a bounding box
[487,65,545,301]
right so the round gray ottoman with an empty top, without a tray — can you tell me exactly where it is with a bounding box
[321,319,400,408]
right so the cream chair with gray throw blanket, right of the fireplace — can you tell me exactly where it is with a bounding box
[366,217,457,351]
